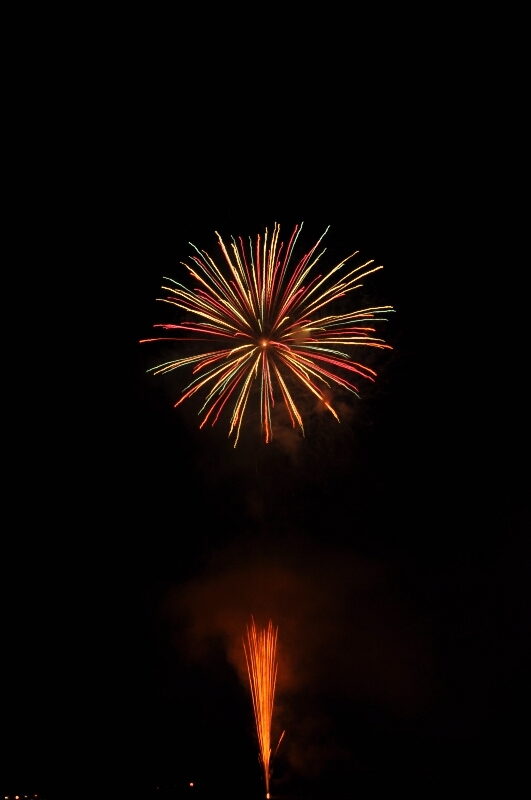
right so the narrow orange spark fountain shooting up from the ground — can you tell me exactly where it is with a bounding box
[243,619,284,797]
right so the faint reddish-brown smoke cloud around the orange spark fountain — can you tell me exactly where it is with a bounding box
[164,539,430,774]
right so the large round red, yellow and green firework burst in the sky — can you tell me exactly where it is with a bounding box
[141,224,392,447]
